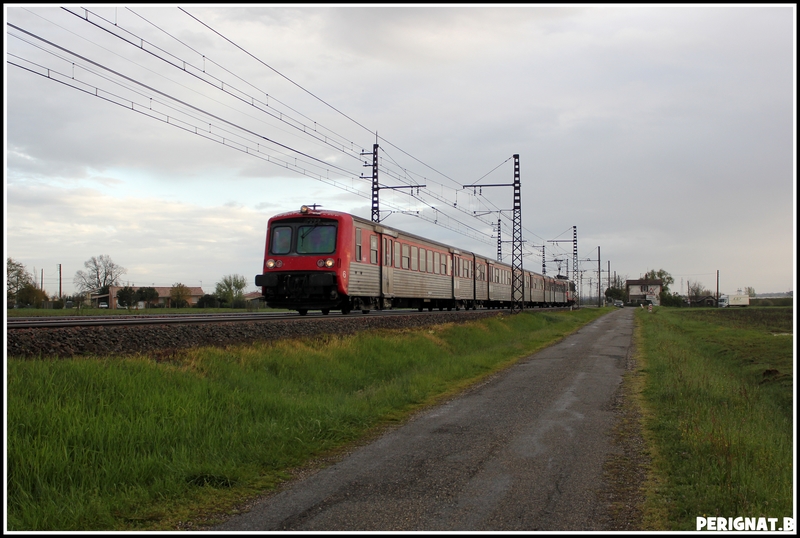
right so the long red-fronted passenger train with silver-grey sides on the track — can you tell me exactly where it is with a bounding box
[255,206,574,315]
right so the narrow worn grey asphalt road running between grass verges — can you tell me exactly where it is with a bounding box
[212,308,633,531]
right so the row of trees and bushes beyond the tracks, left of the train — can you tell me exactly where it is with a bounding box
[6,255,253,308]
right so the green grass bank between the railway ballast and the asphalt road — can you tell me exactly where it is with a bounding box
[7,309,609,531]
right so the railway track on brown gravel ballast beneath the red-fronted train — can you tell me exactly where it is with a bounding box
[6,308,580,358]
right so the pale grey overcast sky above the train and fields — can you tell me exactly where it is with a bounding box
[4,4,797,295]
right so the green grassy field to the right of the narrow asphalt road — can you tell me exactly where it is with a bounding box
[636,308,794,531]
